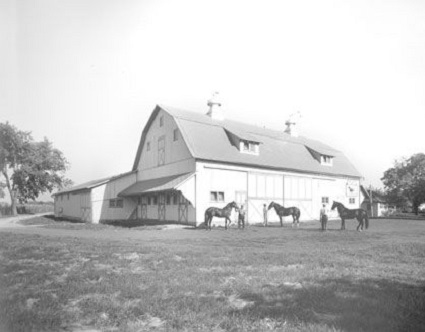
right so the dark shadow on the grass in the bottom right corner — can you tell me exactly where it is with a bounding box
[235,279,425,331]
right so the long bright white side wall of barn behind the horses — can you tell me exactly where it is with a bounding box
[196,162,360,224]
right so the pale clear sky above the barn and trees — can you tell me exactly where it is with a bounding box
[0,0,425,201]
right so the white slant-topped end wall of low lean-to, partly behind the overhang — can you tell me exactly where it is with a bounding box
[92,173,137,223]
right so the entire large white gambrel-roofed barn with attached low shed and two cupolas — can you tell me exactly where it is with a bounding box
[54,99,361,226]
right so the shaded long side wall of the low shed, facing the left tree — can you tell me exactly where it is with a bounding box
[55,190,91,222]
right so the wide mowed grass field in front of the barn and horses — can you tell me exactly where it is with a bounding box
[0,220,425,332]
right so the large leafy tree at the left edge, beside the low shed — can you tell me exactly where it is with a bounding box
[0,122,71,215]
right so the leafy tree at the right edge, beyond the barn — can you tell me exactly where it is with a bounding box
[381,153,425,214]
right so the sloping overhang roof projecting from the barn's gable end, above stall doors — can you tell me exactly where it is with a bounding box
[118,173,195,197]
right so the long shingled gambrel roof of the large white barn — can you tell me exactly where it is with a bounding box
[133,105,362,178]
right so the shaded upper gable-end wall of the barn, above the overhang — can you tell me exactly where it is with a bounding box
[138,110,193,181]
